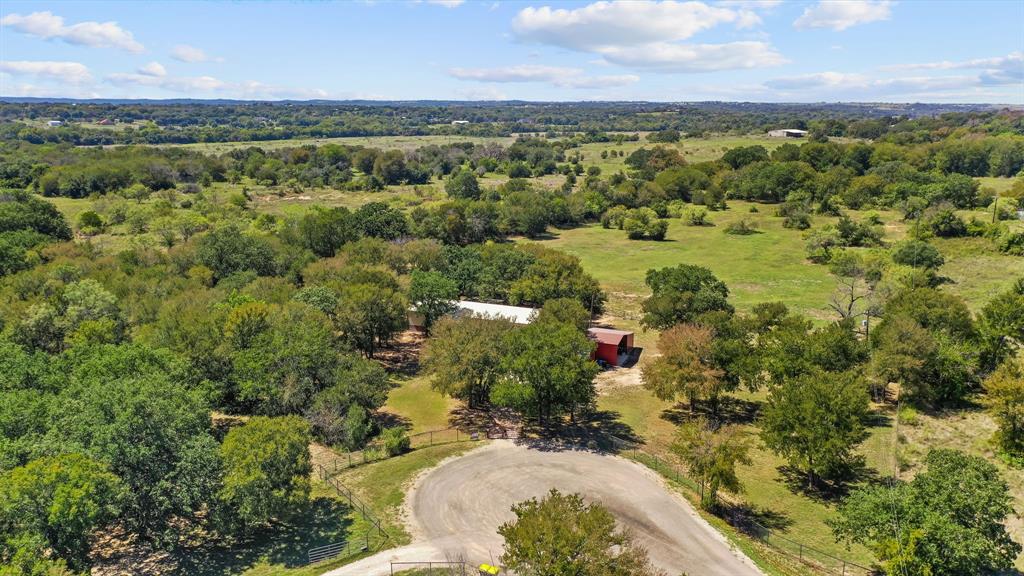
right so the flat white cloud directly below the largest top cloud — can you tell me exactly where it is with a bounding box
[602,41,786,73]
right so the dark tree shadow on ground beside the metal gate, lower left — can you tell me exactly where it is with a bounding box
[171,498,352,576]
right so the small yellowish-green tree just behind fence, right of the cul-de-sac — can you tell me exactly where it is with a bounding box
[672,418,751,509]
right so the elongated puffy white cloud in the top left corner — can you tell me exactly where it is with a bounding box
[0,11,145,53]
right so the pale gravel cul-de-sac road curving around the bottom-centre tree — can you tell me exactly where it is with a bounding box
[325,441,761,576]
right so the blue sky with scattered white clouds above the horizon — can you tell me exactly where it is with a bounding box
[0,0,1024,105]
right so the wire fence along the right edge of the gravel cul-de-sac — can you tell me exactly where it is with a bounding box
[609,436,879,576]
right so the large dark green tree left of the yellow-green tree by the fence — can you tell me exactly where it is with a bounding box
[45,344,219,541]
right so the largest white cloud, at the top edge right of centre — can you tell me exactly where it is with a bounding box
[512,0,749,51]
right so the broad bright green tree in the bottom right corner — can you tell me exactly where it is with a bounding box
[831,449,1021,576]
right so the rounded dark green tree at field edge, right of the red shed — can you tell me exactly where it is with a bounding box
[642,264,733,330]
